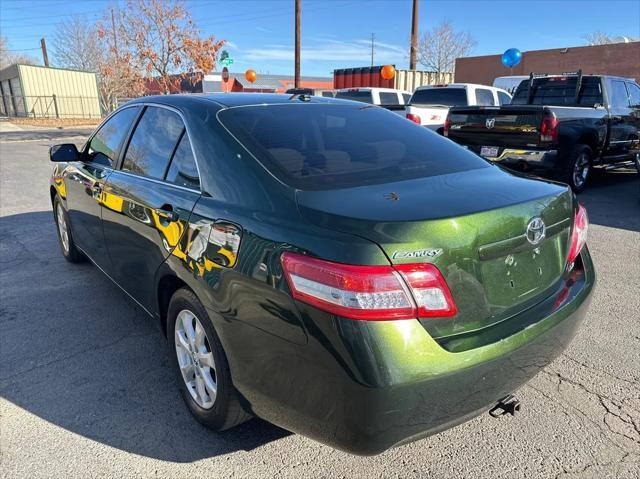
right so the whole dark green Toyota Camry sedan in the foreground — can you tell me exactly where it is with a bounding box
[50,93,595,455]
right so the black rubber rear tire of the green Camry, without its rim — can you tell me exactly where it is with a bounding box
[167,288,252,431]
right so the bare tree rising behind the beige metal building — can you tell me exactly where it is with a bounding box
[52,15,105,73]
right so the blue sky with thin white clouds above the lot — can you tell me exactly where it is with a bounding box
[0,0,640,76]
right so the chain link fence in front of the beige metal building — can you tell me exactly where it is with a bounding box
[0,95,104,119]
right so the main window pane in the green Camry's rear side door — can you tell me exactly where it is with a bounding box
[122,106,184,179]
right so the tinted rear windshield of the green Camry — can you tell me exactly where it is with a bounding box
[219,104,489,190]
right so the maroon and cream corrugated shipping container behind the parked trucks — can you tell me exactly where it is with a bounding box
[333,66,453,92]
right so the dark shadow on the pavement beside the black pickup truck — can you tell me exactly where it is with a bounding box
[578,170,640,231]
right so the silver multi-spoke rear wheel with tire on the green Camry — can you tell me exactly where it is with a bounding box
[167,288,251,431]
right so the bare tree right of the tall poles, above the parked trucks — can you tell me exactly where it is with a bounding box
[418,20,476,78]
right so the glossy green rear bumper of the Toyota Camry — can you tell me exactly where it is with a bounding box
[220,248,595,455]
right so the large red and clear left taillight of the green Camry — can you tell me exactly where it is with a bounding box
[282,252,457,321]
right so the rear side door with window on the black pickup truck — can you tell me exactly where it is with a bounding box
[607,79,636,160]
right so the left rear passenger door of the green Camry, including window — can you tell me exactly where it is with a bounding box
[102,105,200,310]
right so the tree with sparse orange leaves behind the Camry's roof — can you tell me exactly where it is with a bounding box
[120,0,225,93]
